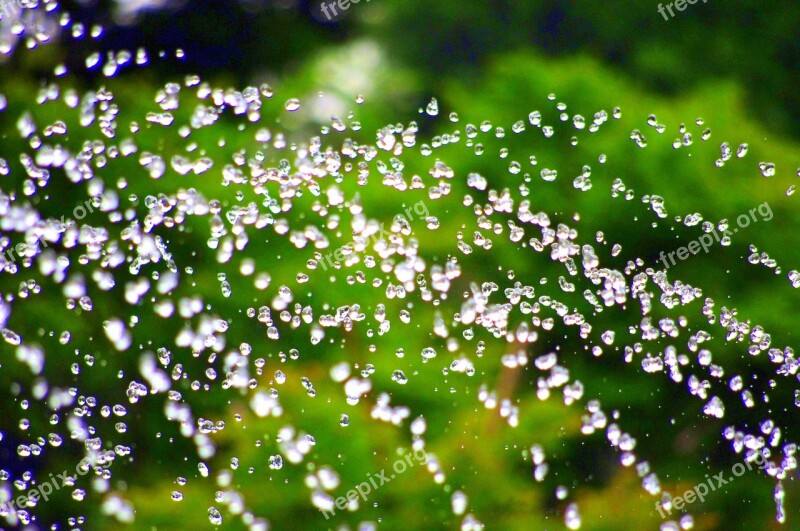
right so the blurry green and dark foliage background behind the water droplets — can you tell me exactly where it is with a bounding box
[0,0,800,530]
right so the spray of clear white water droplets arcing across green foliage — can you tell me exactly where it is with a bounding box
[0,2,800,529]
